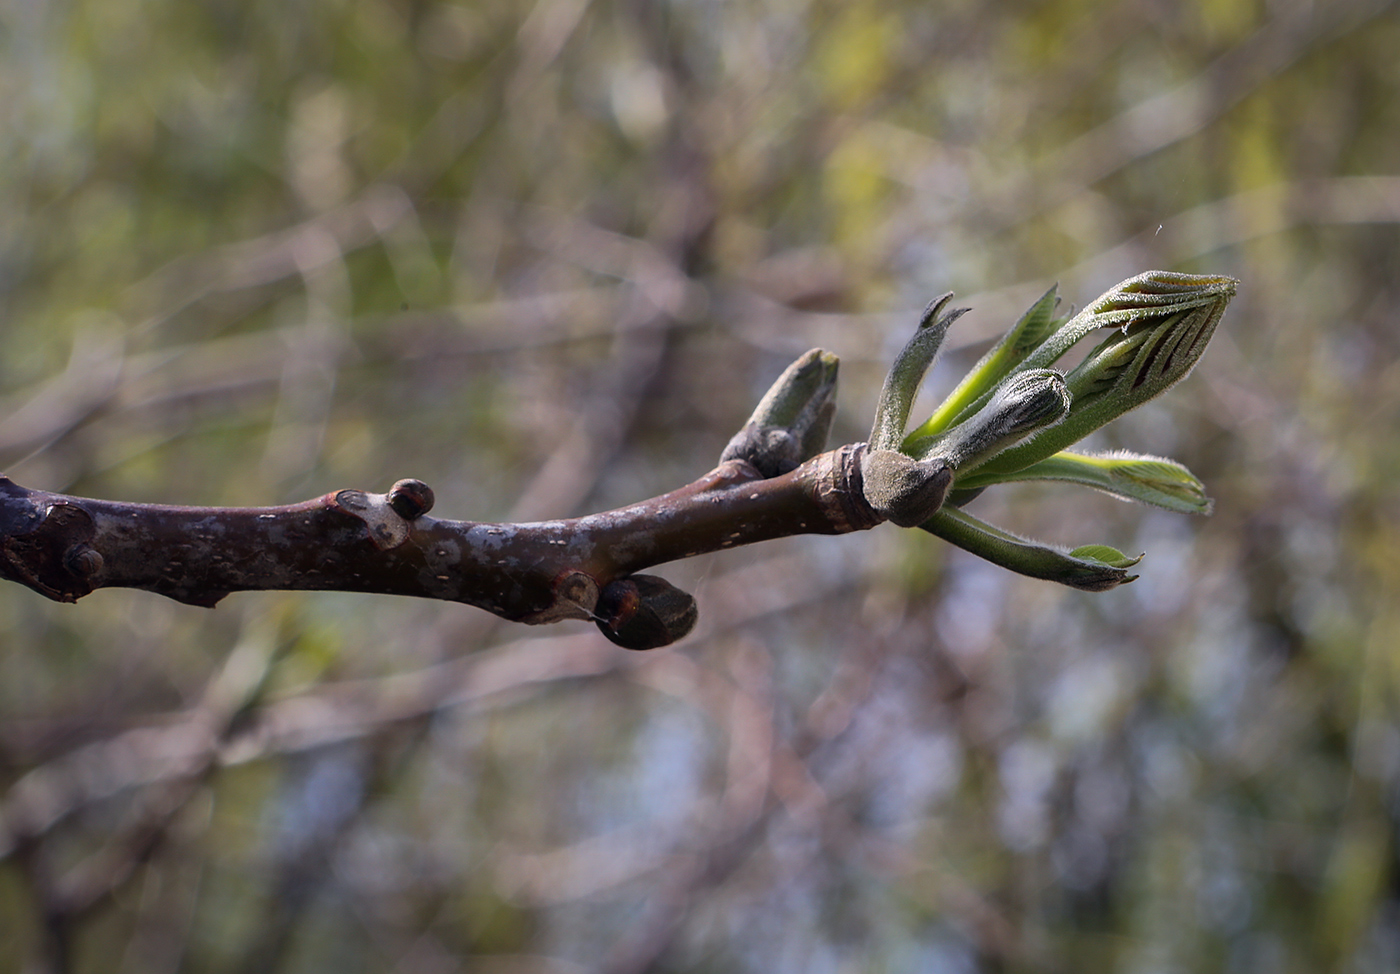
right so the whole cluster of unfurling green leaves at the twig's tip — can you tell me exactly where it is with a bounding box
[862,270,1238,592]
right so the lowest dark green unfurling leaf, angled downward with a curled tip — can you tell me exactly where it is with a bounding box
[920,505,1141,592]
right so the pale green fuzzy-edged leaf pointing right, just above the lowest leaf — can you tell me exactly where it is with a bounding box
[959,451,1211,514]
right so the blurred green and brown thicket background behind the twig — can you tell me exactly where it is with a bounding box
[0,0,1400,974]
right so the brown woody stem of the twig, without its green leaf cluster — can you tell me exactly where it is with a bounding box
[0,444,885,649]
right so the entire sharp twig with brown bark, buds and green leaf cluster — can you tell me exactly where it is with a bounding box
[0,271,1236,649]
